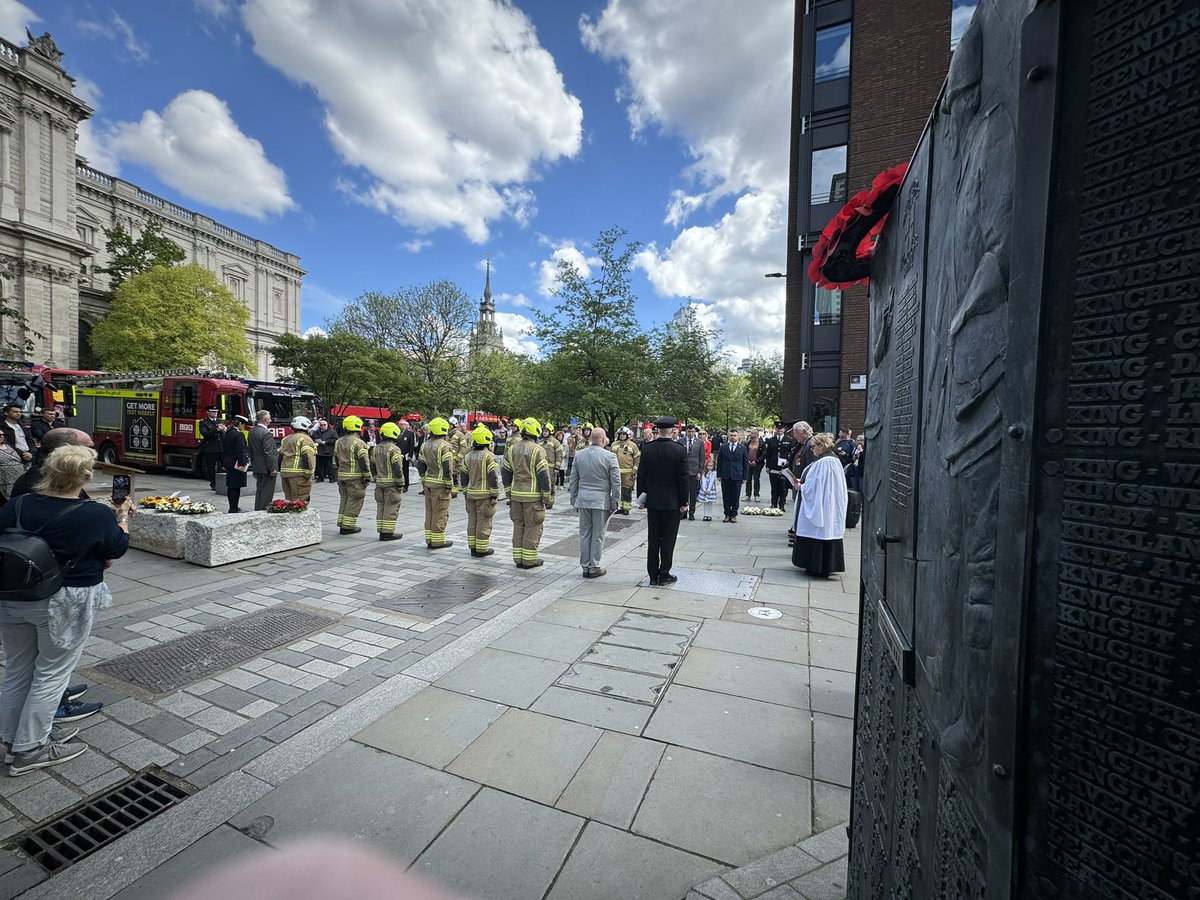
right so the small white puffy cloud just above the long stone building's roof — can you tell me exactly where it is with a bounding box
[104,90,295,218]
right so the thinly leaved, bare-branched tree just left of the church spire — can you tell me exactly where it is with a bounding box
[329,281,475,409]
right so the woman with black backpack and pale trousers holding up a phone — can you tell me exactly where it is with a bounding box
[0,446,132,775]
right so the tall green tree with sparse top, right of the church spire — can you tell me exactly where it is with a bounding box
[534,228,653,432]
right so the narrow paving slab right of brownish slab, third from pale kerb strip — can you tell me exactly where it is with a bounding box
[554,731,666,829]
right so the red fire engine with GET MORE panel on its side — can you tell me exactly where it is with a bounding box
[66,372,319,474]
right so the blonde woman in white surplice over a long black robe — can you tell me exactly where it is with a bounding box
[792,434,846,578]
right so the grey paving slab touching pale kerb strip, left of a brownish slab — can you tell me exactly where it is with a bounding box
[354,686,508,769]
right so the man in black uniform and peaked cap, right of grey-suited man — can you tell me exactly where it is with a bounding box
[637,416,688,586]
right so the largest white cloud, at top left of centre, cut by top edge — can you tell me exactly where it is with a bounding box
[242,0,583,242]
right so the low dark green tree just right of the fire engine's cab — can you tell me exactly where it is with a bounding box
[271,332,424,410]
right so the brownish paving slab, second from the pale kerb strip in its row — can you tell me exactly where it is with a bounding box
[446,709,604,805]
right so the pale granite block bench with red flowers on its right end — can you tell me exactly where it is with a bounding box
[180,509,320,566]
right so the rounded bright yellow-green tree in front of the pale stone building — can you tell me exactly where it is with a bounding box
[91,265,251,372]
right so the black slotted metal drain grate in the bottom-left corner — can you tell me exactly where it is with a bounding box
[20,773,188,872]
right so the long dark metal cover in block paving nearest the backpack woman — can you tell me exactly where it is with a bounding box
[96,606,337,694]
